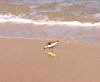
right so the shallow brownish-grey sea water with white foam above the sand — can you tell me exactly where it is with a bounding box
[0,0,100,44]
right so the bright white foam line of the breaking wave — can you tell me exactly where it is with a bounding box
[0,14,100,26]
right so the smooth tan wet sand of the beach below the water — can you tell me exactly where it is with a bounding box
[0,38,100,82]
